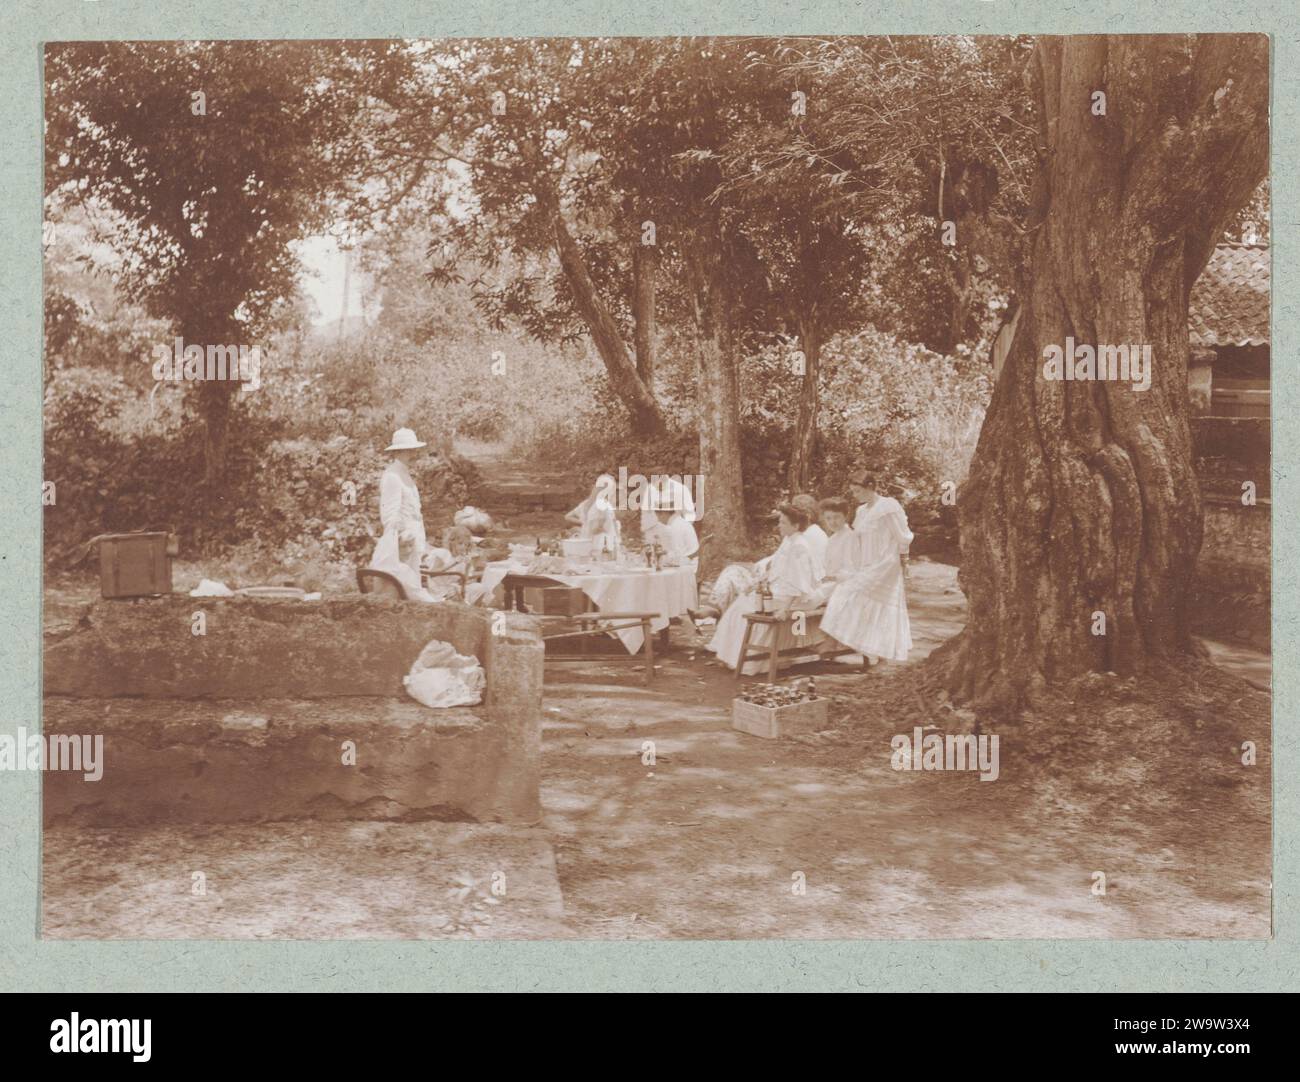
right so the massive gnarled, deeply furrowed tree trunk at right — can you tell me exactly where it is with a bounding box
[952,35,1269,706]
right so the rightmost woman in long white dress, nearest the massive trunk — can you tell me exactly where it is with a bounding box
[822,473,913,661]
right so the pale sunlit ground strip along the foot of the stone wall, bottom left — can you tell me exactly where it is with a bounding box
[42,821,567,939]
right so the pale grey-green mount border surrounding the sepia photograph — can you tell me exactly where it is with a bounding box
[0,0,1300,992]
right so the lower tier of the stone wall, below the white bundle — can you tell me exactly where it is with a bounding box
[43,696,541,826]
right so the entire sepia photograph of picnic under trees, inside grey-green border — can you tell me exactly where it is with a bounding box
[35,33,1282,941]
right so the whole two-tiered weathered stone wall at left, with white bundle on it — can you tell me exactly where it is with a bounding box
[44,596,542,826]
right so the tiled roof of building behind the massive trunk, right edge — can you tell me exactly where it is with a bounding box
[1187,244,1269,346]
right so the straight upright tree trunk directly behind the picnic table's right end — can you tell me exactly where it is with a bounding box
[685,241,749,568]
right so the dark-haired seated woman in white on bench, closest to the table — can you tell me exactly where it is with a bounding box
[706,503,822,675]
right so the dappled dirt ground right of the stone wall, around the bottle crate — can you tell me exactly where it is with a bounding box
[542,564,1269,939]
